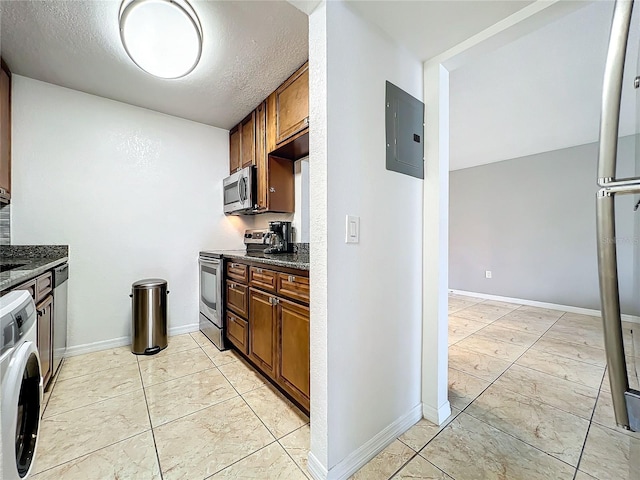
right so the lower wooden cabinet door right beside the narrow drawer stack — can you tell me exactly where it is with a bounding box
[249,288,277,377]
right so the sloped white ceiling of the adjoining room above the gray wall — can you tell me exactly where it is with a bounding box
[450,2,640,170]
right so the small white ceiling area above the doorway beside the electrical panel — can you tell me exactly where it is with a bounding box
[347,0,533,61]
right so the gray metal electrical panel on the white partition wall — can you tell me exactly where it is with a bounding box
[385,82,424,178]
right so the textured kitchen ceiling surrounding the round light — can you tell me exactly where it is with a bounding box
[0,0,308,129]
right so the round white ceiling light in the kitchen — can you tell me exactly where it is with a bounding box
[119,0,202,78]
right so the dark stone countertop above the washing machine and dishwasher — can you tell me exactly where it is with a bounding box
[0,245,69,292]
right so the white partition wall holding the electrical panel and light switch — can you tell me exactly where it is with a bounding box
[309,2,422,478]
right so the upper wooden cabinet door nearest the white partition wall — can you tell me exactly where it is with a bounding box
[276,63,309,144]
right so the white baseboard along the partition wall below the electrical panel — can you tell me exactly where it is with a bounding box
[308,404,422,480]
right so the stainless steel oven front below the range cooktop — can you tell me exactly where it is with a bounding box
[199,257,224,350]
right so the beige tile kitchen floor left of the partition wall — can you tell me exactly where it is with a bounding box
[33,332,309,480]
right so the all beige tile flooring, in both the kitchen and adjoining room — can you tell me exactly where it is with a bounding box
[34,295,640,480]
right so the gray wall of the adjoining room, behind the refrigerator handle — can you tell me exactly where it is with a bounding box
[449,135,640,315]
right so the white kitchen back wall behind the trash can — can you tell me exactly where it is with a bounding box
[11,75,250,346]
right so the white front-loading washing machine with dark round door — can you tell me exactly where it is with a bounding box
[0,291,42,480]
